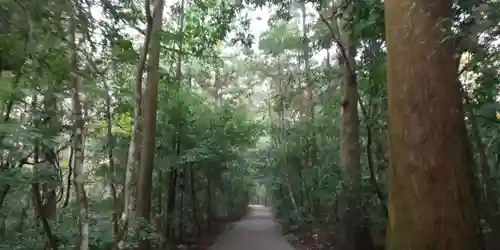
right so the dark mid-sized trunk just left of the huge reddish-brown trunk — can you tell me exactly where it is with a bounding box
[338,2,373,250]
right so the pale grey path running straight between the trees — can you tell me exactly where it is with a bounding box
[209,206,294,250]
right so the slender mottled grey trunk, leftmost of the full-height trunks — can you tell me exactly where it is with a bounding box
[69,7,89,250]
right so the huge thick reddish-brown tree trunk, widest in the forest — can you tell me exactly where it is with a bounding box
[385,0,481,250]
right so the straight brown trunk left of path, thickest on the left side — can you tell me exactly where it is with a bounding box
[137,0,164,250]
